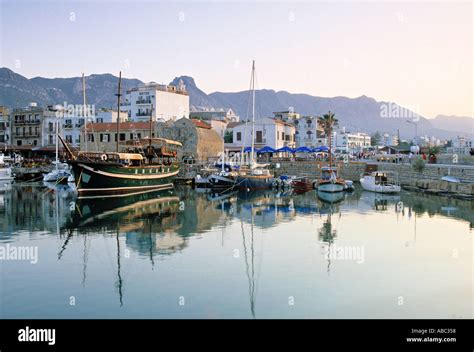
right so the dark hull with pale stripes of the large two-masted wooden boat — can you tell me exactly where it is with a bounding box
[70,162,179,195]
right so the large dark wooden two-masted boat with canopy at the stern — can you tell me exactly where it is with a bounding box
[59,72,181,196]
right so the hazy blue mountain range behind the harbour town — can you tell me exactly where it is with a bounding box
[0,68,474,139]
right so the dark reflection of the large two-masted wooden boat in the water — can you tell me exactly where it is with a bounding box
[63,190,181,306]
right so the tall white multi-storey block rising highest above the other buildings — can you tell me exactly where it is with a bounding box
[122,81,189,122]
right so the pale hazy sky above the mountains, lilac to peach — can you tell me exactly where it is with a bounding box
[0,0,474,118]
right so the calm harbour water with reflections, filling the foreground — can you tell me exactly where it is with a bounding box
[0,184,474,319]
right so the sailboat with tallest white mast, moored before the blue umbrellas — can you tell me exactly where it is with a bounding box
[237,60,274,190]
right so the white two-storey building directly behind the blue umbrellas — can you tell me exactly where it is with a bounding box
[224,117,296,151]
